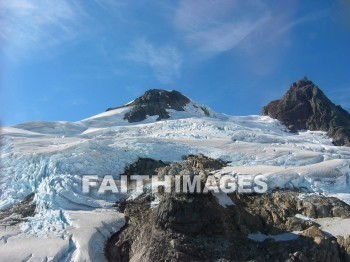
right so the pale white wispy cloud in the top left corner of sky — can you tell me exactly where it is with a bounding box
[0,0,84,59]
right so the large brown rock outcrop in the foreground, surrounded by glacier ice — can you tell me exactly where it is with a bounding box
[105,155,350,262]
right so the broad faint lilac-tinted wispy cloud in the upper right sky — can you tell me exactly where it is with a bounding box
[173,0,330,75]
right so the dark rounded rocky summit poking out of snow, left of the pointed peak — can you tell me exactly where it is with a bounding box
[107,89,210,123]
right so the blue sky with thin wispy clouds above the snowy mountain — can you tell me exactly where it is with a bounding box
[0,0,350,125]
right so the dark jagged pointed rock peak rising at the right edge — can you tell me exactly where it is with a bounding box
[263,77,350,146]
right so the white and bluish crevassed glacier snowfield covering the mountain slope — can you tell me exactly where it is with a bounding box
[0,103,350,261]
